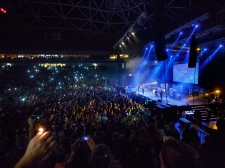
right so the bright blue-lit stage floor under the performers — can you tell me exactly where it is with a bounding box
[131,88,205,106]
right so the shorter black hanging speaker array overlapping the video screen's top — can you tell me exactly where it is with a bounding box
[188,36,198,68]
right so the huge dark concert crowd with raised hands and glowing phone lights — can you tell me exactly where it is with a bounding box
[0,65,225,168]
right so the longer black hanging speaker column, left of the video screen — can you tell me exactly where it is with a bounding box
[153,1,168,61]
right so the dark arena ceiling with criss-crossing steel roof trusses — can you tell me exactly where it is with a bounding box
[0,0,225,53]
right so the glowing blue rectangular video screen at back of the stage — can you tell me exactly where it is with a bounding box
[173,62,199,84]
